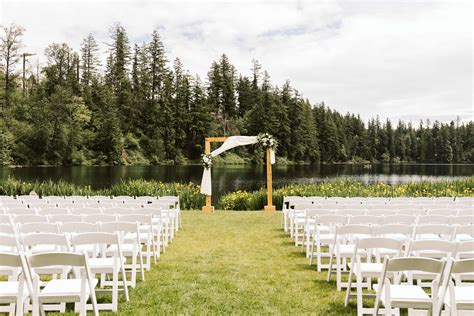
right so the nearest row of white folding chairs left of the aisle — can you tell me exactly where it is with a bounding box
[0,252,101,316]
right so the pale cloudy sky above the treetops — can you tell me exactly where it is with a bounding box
[0,0,474,123]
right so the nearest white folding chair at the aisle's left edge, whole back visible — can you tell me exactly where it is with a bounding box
[27,252,99,316]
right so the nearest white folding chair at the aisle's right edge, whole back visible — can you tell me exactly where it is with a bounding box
[373,257,445,315]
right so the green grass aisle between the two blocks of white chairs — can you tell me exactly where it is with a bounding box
[119,211,355,315]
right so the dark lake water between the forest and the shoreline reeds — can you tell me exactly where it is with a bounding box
[0,164,474,198]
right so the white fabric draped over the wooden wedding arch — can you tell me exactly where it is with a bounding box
[201,136,275,195]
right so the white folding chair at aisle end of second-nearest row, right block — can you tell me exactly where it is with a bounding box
[345,237,403,315]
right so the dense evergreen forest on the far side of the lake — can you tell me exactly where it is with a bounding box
[0,24,474,165]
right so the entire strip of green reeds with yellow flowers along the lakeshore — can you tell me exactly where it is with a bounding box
[0,177,474,210]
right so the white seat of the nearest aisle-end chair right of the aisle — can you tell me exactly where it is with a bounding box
[373,284,432,309]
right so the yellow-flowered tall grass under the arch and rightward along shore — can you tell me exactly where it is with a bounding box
[219,177,474,210]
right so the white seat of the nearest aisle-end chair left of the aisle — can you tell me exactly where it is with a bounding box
[38,279,98,303]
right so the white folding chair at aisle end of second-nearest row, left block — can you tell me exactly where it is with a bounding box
[71,232,129,312]
